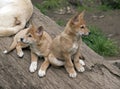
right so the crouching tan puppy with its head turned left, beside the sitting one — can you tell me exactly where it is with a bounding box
[4,24,64,77]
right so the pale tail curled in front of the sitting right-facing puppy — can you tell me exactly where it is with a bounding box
[49,54,65,66]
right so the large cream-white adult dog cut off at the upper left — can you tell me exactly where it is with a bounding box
[0,0,33,36]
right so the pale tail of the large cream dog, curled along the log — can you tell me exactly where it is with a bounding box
[0,21,25,37]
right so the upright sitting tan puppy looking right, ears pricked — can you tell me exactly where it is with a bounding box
[50,11,89,77]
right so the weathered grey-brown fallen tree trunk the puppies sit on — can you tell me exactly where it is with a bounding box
[0,8,120,89]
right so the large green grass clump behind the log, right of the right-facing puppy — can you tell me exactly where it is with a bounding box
[83,26,120,56]
